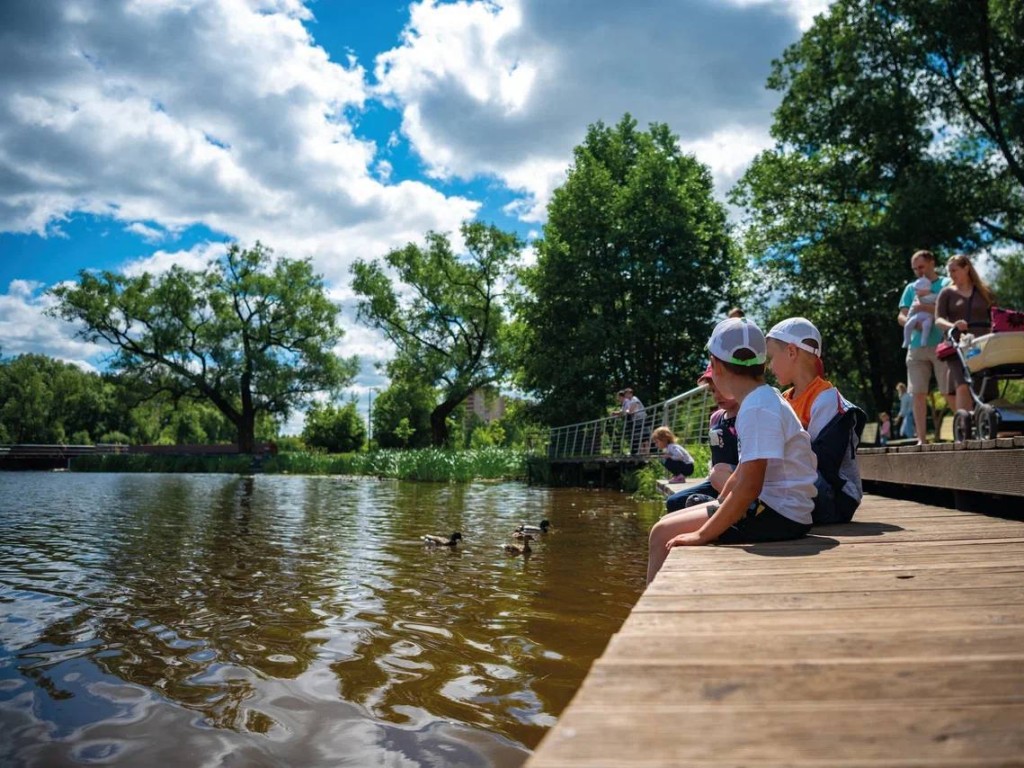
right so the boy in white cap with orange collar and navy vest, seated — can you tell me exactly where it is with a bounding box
[768,317,867,525]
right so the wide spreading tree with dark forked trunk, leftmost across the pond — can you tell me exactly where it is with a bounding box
[52,243,356,453]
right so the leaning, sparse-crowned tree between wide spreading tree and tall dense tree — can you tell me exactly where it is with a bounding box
[352,222,523,445]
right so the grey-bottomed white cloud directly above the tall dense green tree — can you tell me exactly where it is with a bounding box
[375,0,827,221]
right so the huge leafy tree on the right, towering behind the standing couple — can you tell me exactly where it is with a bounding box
[732,0,1020,411]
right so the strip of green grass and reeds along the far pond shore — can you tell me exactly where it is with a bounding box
[72,447,526,482]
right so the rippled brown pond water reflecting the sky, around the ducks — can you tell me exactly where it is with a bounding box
[0,473,658,768]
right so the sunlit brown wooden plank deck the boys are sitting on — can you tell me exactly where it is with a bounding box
[526,496,1024,768]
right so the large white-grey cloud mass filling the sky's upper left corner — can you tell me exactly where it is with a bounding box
[0,0,477,274]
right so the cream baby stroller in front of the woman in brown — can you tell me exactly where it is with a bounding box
[948,308,1024,442]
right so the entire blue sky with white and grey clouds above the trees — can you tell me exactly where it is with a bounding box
[0,0,826,434]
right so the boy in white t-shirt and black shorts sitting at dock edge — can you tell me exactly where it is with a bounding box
[647,317,817,584]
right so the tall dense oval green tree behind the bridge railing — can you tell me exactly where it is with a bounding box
[515,115,736,423]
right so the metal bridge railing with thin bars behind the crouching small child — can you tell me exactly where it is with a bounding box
[539,387,714,459]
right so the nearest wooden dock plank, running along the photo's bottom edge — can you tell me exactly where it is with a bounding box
[527,701,1024,768]
